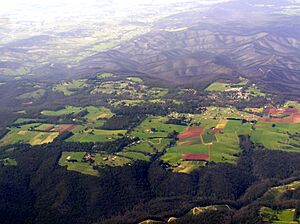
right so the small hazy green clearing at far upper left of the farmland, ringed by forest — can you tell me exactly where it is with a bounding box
[52,79,87,96]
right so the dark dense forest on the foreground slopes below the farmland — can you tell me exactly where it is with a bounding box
[0,136,300,224]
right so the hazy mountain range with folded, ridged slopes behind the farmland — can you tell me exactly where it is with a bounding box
[72,19,300,94]
